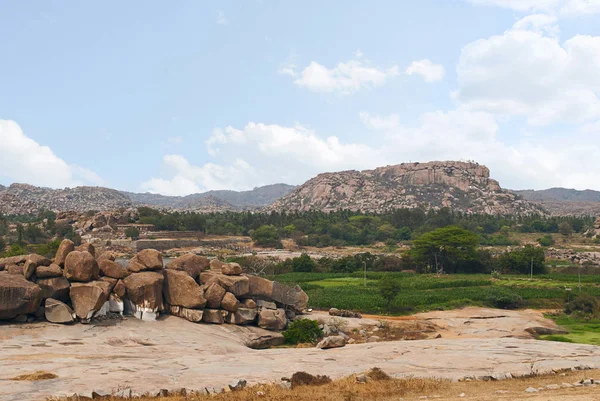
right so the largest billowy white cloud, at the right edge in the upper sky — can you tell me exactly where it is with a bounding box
[455,16,600,125]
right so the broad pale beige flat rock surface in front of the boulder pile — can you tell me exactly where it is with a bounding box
[0,312,600,401]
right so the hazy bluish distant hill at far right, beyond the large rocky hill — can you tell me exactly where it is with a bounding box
[514,188,600,216]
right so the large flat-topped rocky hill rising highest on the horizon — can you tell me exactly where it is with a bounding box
[269,161,545,215]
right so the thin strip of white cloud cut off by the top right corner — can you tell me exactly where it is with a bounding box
[467,0,600,16]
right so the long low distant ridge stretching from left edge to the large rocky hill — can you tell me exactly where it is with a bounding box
[0,184,294,214]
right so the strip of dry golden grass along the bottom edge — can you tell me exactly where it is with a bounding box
[54,368,600,401]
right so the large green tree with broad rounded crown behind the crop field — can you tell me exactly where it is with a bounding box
[411,226,480,273]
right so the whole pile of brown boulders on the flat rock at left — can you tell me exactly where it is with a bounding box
[0,240,308,330]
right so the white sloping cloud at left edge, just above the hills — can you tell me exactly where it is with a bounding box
[0,120,103,188]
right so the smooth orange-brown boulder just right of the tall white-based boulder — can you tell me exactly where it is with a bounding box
[163,269,206,309]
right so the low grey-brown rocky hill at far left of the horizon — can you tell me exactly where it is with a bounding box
[0,184,133,214]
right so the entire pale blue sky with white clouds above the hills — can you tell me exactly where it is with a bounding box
[0,0,600,195]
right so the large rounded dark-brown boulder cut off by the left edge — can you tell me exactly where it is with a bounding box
[0,273,42,320]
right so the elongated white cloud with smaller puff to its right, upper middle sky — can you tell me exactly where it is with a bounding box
[290,53,398,95]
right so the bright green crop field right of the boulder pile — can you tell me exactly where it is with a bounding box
[272,272,600,315]
